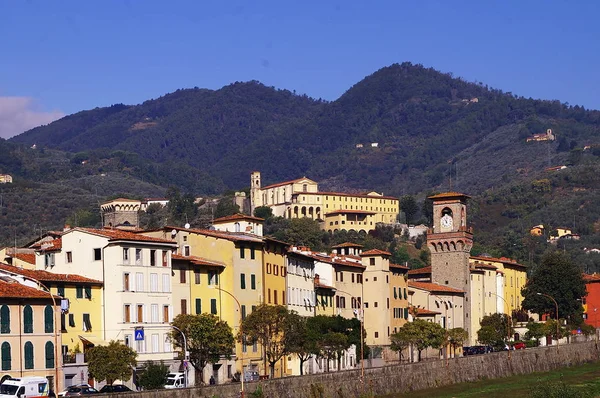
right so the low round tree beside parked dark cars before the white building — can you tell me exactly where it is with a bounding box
[87,340,137,384]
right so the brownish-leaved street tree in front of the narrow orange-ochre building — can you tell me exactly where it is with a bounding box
[238,304,292,378]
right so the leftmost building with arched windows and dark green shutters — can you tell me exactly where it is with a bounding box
[0,273,63,391]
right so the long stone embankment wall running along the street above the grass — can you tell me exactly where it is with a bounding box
[112,341,599,398]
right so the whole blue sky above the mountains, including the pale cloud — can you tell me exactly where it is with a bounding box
[0,0,600,137]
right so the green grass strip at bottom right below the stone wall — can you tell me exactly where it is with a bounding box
[380,362,600,398]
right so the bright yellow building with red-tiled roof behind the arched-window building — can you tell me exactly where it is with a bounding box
[0,264,102,355]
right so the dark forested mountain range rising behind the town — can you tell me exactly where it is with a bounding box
[0,59,600,258]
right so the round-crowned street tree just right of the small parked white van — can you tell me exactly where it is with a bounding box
[171,313,235,382]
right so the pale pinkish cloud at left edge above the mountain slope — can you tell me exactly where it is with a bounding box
[0,97,64,138]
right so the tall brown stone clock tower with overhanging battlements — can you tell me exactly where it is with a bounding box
[427,192,473,335]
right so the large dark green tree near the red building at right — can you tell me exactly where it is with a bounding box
[522,251,587,324]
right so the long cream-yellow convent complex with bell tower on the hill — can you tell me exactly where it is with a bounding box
[250,171,400,232]
